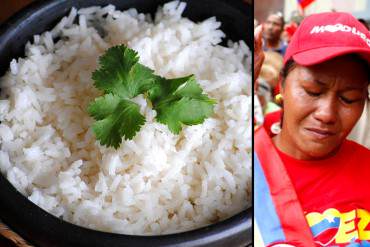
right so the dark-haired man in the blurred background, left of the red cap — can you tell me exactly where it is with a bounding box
[263,12,287,56]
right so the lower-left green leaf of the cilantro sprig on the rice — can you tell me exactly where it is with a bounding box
[88,94,145,149]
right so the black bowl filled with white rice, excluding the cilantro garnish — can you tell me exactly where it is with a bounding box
[0,0,253,246]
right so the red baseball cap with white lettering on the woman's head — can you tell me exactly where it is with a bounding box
[284,12,370,66]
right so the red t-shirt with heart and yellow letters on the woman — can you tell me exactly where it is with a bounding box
[278,140,370,246]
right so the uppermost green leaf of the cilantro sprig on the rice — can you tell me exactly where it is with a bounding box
[92,45,156,99]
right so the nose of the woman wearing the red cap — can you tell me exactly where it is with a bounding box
[314,96,338,124]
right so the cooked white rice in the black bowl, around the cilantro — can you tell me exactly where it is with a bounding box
[0,1,252,235]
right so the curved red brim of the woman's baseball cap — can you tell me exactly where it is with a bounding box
[293,47,370,66]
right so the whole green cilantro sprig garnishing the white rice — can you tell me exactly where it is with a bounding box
[88,45,216,149]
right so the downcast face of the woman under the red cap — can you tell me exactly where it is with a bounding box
[275,56,368,160]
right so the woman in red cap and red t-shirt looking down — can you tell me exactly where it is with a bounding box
[254,12,370,246]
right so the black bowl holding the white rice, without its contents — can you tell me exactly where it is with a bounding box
[0,0,253,247]
